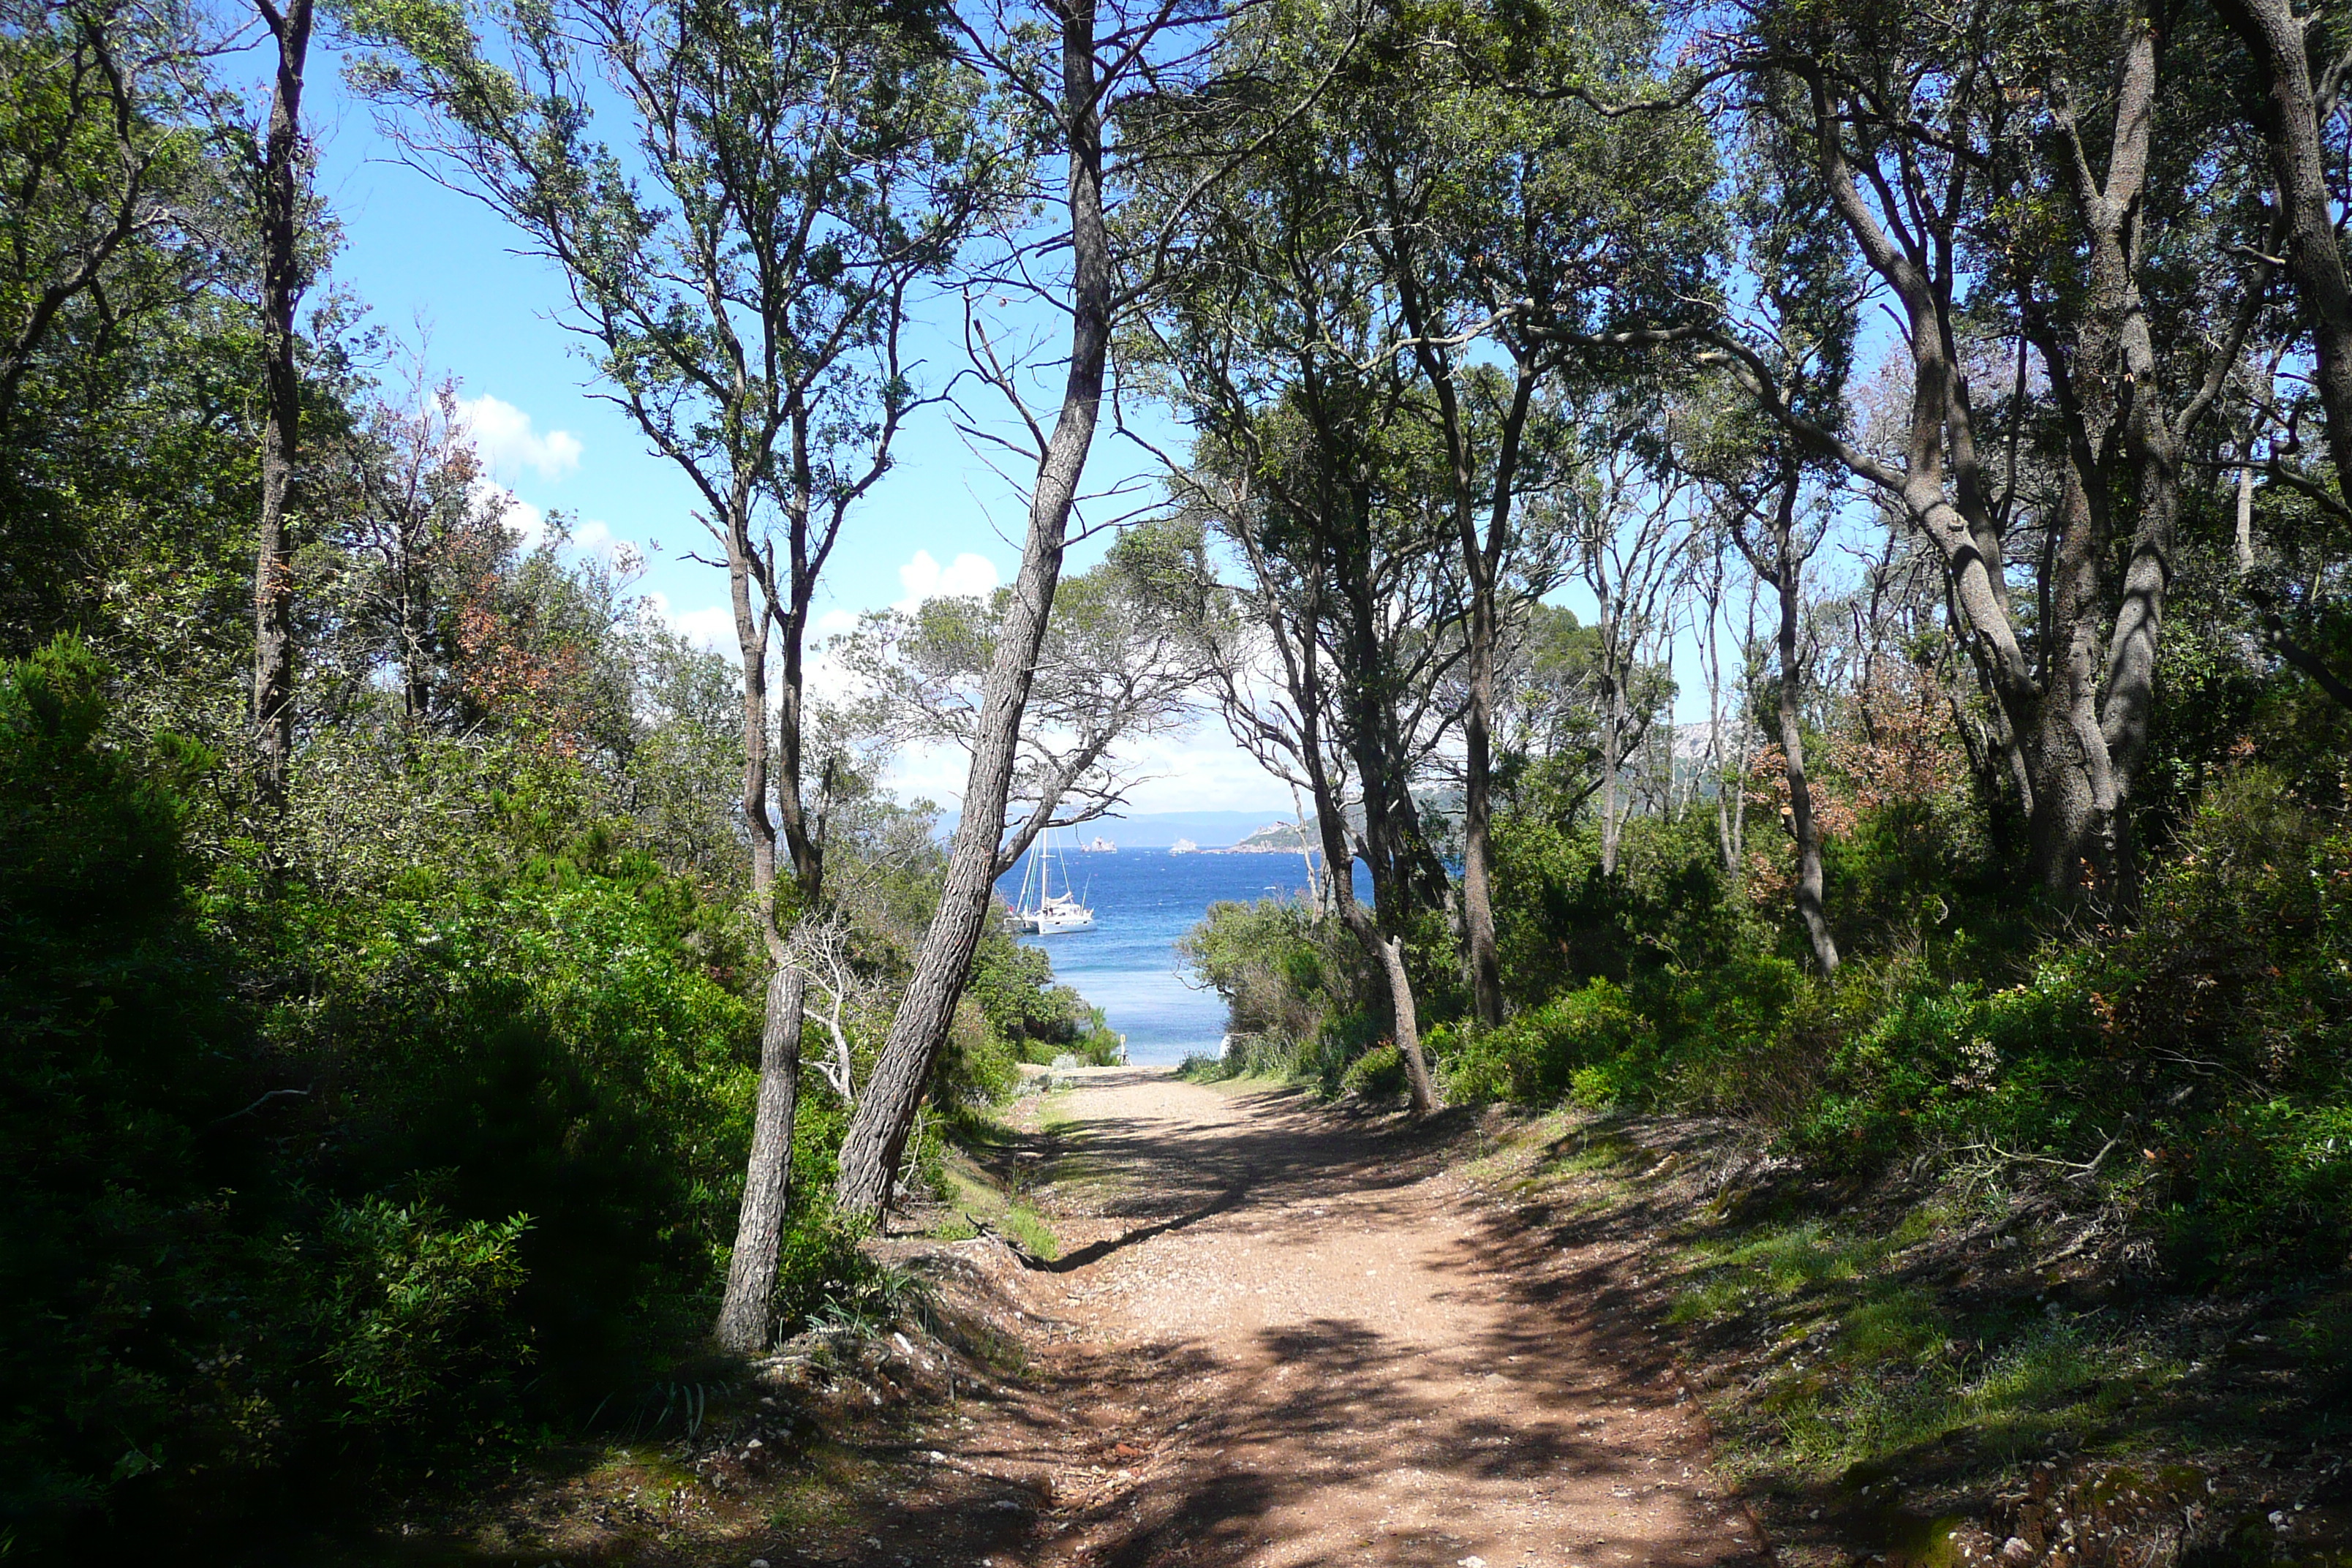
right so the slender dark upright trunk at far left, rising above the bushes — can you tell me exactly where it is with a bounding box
[252,0,311,811]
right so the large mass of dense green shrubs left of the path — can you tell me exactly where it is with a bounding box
[0,642,776,1545]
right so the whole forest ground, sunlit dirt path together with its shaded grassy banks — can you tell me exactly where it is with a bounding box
[347,1070,2352,1568]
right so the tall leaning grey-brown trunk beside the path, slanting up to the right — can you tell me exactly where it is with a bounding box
[835,0,1110,1220]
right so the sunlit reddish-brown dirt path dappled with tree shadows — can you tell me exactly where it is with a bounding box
[912,1070,1760,1568]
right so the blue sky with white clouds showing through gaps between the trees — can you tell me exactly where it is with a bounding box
[308,54,1768,818]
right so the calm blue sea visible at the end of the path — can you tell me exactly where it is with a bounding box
[998,848,1335,1063]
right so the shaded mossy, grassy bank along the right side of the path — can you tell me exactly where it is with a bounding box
[1472,1112,2352,1566]
